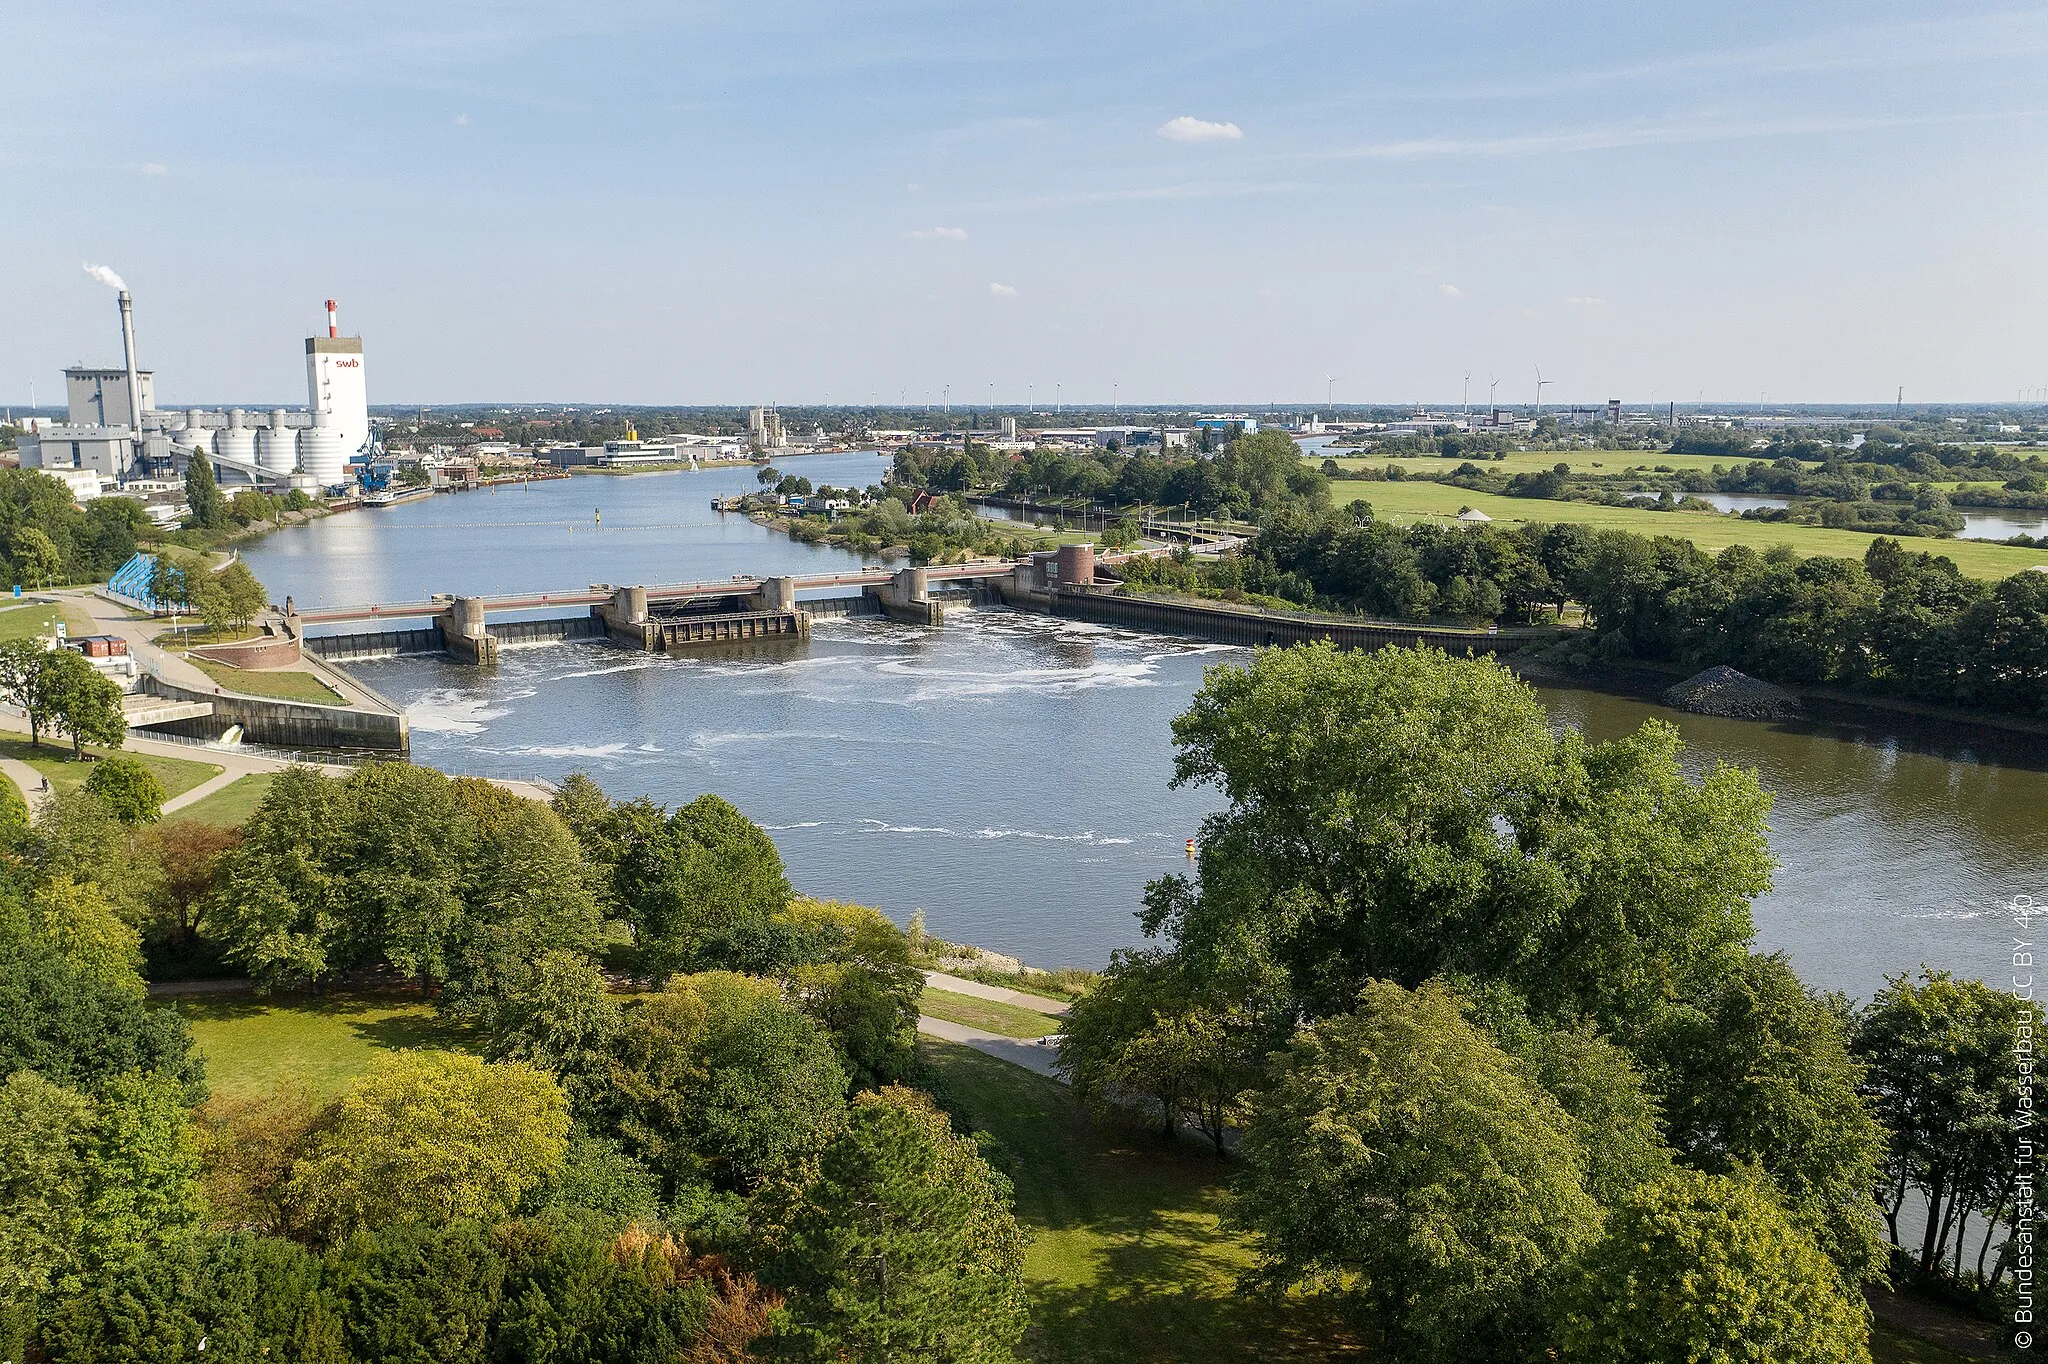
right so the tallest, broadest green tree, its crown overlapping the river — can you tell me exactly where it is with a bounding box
[1143,645,1772,1034]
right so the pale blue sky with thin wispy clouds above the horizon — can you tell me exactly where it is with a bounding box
[0,0,2048,406]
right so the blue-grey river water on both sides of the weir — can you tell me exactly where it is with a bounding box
[246,455,2048,997]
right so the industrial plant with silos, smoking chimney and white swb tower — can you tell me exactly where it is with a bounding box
[20,280,371,496]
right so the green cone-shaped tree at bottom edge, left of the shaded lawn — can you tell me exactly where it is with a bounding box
[764,1085,1026,1364]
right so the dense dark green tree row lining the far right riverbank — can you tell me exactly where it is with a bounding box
[1120,502,2048,715]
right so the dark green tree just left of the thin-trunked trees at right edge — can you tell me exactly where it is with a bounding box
[1642,954,1884,1282]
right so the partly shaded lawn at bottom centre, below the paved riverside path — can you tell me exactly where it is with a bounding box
[920,1040,1358,1364]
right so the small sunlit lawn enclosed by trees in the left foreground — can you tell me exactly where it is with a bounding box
[170,993,469,1098]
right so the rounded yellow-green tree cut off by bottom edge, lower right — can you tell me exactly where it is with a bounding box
[1556,1169,1870,1364]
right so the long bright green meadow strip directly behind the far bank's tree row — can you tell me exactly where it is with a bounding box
[1331,481,2048,578]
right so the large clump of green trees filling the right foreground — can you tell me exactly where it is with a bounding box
[1061,647,2038,1360]
